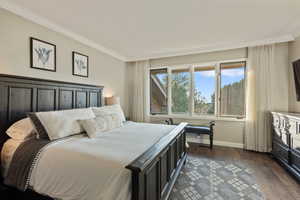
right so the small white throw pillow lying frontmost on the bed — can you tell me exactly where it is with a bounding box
[78,118,107,138]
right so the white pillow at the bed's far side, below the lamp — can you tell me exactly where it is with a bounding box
[92,104,126,122]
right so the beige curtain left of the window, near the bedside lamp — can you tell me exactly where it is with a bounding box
[129,61,150,122]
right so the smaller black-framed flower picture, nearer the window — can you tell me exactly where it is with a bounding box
[72,51,89,77]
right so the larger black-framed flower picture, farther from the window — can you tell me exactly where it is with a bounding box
[30,37,56,72]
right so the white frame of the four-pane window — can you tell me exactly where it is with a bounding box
[146,58,248,120]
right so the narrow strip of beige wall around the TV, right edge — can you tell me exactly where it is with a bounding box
[288,36,300,112]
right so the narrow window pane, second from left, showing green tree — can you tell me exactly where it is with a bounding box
[171,69,190,114]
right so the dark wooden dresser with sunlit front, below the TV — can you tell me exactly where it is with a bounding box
[272,112,300,181]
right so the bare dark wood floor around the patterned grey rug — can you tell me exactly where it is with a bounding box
[188,144,300,200]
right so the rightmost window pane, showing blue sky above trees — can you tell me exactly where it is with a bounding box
[220,62,246,116]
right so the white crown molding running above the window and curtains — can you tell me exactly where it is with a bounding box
[126,34,295,62]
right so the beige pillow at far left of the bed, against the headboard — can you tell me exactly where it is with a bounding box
[6,117,36,140]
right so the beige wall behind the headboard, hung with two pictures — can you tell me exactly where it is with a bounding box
[0,9,127,114]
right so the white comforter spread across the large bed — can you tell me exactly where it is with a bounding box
[30,122,174,200]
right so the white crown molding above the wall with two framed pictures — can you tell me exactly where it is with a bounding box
[0,0,127,61]
